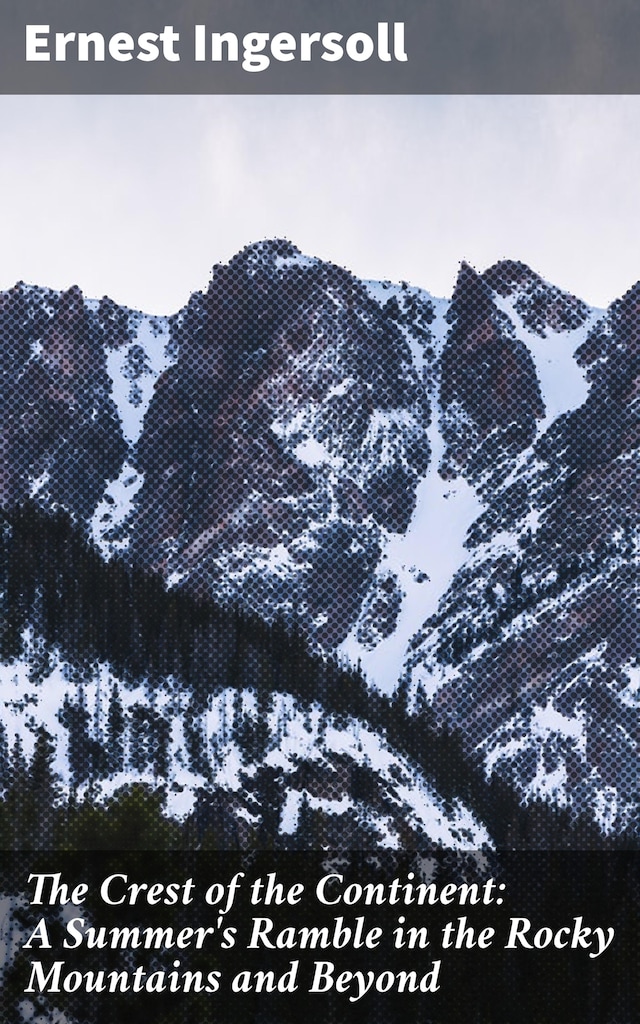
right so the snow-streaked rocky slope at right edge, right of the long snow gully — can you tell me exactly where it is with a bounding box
[409,278,640,831]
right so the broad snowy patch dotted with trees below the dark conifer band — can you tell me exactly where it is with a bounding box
[0,633,490,850]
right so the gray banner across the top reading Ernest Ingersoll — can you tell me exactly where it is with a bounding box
[0,0,640,93]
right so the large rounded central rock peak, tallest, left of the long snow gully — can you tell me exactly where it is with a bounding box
[133,242,428,646]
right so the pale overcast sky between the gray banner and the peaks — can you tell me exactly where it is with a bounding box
[0,96,640,313]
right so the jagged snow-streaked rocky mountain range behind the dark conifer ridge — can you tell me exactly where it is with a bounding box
[0,240,640,845]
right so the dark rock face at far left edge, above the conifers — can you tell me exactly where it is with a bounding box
[0,285,125,520]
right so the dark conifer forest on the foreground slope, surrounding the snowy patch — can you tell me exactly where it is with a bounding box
[0,504,634,849]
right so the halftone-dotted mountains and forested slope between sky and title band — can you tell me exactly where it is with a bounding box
[0,240,640,872]
